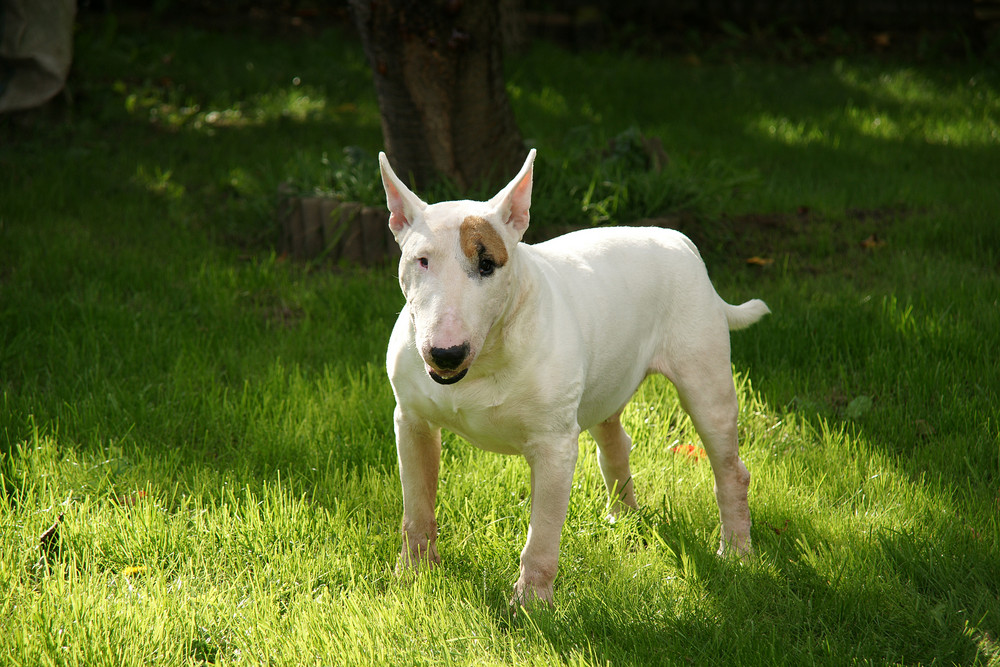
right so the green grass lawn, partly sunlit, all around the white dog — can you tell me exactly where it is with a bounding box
[0,15,1000,665]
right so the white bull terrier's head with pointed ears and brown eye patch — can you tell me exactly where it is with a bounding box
[379,149,535,384]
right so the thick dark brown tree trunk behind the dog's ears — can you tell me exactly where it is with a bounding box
[351,0,525,189]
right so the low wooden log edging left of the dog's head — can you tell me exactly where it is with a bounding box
[278,188,400,266]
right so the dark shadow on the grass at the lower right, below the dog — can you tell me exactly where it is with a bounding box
[495,518,998,665]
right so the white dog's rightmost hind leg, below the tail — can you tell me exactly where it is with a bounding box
[668,348,752,556]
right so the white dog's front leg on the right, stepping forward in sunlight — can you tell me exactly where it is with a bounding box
[511,434,579,606]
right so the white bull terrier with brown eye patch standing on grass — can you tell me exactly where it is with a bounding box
[379,150,769,604]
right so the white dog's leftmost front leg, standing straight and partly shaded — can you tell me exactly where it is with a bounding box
[395,406,441,571]
